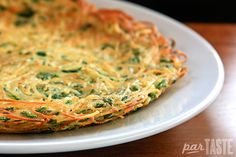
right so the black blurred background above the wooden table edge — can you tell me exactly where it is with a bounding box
[127,0,236,22]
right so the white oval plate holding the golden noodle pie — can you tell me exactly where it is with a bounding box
[0,0,224,153]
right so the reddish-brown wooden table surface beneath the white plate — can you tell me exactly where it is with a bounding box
[4,23,236,157]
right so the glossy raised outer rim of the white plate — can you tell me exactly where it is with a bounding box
[0,0,225,154]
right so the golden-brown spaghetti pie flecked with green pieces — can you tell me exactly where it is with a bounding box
[0,0,186,133]
